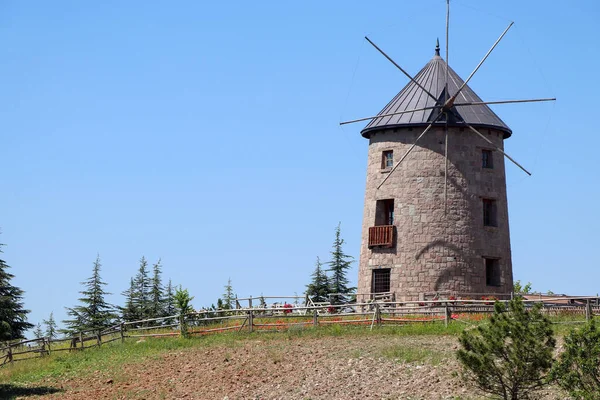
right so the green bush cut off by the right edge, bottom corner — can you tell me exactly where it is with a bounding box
[550,320,600,400]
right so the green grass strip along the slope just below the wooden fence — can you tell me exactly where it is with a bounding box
[0,322,573,399]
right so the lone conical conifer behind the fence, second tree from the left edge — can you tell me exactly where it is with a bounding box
[64,255,116,333]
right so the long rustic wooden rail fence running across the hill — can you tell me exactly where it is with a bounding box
[0,296,600,366]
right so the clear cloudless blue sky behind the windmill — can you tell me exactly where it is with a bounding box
[0,0,600,332]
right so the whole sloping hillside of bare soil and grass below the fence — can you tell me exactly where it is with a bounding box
[0,326,564,400]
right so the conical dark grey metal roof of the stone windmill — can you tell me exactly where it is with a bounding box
[361,49,512,138]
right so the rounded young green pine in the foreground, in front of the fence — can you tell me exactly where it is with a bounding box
[457,297,556,400]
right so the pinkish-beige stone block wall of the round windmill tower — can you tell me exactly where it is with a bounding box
[358,127,513,301]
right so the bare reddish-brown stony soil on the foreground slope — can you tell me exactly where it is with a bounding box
[28,336,565,400]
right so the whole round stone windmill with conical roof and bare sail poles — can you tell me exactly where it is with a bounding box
[343,5,554,300]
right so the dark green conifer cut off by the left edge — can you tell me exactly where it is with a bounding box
[0,244,34,341]
